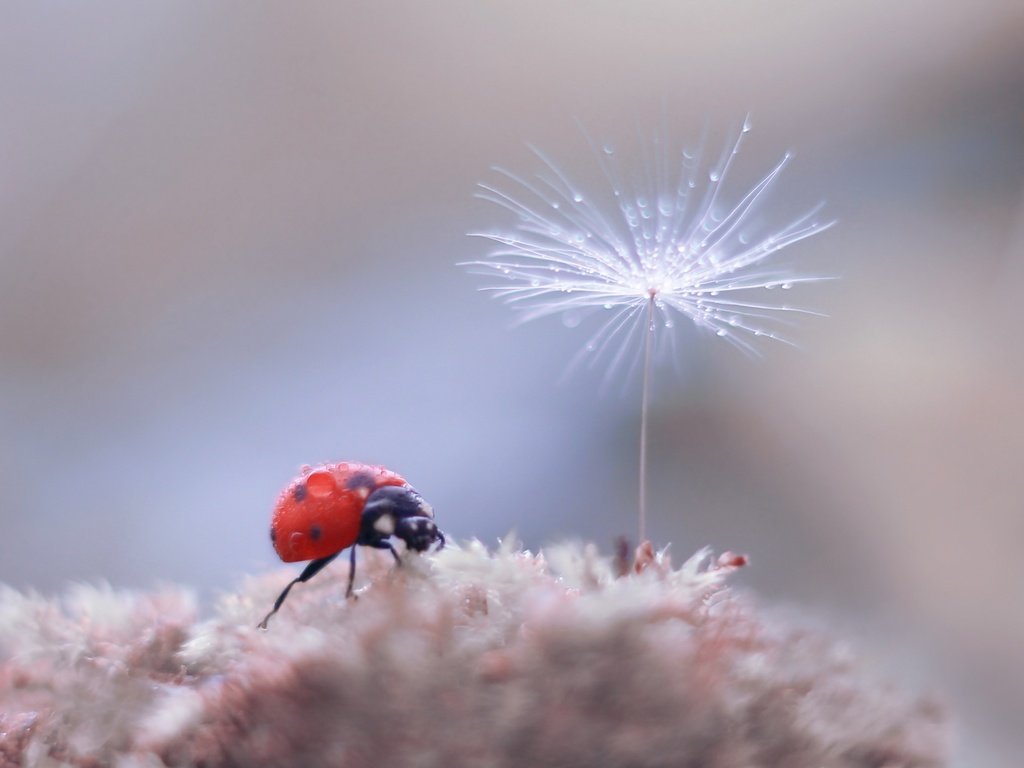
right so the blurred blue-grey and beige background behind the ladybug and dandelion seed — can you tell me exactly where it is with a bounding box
[0,0,1024,768]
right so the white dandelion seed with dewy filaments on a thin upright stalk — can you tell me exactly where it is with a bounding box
[464,118,834,541]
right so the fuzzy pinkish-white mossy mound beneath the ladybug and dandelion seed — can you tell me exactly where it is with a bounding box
[0,541,947,768]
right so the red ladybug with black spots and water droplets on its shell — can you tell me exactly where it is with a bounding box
[259,462,444,630]
